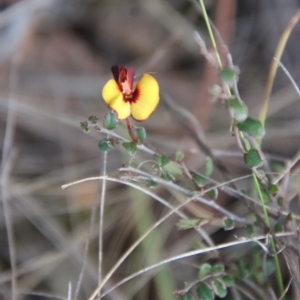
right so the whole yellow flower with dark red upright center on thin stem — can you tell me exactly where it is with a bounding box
[102,66,159,121]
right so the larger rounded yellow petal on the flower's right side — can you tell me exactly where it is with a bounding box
[131,74,159,121]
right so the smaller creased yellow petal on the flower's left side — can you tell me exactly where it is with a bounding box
[102,79,130,120]
